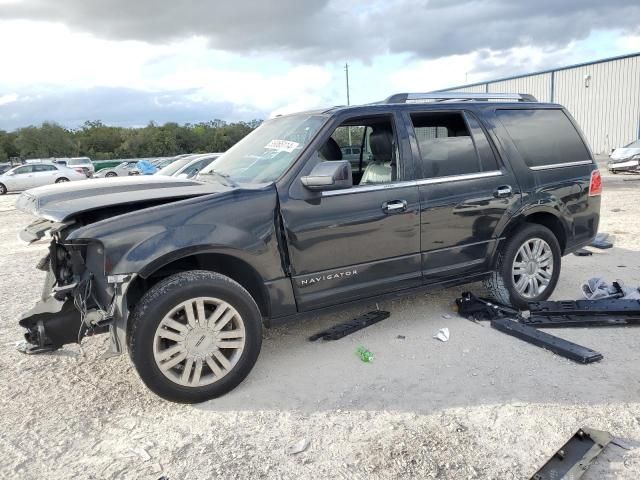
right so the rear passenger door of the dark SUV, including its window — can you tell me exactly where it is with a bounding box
[405,110,521,283]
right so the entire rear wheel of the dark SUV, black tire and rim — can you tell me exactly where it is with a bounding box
[484,224,562,309]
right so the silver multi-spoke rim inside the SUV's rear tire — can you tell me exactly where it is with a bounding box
[511,238,553,298]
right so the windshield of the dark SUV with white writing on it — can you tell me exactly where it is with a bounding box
[199,114,326,183]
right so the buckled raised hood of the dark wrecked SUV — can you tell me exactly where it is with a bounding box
[16,175,230,222]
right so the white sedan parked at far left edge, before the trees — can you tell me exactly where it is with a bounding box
[0,163,87,195]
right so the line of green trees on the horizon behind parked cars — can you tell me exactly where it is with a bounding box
[0,120,261,160]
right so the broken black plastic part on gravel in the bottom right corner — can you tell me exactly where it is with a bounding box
[531,428,613,480]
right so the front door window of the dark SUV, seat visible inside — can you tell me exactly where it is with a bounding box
[318,115,398,186]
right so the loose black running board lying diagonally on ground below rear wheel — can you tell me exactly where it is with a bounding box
[491,318,603,363]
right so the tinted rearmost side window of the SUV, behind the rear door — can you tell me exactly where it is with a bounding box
[496,109,591,167]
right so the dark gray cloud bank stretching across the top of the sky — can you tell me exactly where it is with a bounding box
[0,0,640,63]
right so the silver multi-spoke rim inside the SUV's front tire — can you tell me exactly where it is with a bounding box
[153,297,246,387]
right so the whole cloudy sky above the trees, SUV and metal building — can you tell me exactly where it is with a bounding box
[0,0,640,130]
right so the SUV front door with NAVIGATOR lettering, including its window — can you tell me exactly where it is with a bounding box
[280,113,421,311]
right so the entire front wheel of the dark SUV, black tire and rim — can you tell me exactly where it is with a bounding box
[127,270,262,403]
